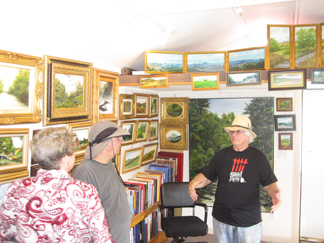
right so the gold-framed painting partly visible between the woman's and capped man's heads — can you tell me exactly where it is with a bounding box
[67,122,92,163]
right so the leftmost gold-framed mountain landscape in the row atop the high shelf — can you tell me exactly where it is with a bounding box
[145,51,184,74]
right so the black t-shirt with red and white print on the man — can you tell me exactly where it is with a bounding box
[202,146,277,227]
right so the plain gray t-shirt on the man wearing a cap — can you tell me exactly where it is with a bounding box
[72,159,132,243]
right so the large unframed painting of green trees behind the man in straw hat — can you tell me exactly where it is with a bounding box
[189,97,274,212]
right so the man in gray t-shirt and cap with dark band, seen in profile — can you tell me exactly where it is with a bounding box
[73,121,132,243]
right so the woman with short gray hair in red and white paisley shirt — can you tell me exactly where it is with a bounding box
[0,127,113,243]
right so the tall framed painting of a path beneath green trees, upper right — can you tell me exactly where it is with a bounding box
[293,25,319,68]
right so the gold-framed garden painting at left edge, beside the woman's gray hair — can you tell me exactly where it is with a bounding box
[0,128,29,183]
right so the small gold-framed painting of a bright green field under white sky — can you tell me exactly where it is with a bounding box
[191,73,220,90]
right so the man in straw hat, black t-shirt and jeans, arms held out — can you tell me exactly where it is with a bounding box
[189,116,281,243]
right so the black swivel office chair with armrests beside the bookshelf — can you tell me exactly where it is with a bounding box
[160,182,208,243]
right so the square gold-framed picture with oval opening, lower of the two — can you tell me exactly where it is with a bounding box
[160,124,188,150]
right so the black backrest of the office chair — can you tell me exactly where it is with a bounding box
[161,182,194,208]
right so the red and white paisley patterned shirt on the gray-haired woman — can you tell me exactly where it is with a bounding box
[0,169,113,243]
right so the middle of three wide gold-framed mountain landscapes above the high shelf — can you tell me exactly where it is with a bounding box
[185,51,226,73]
